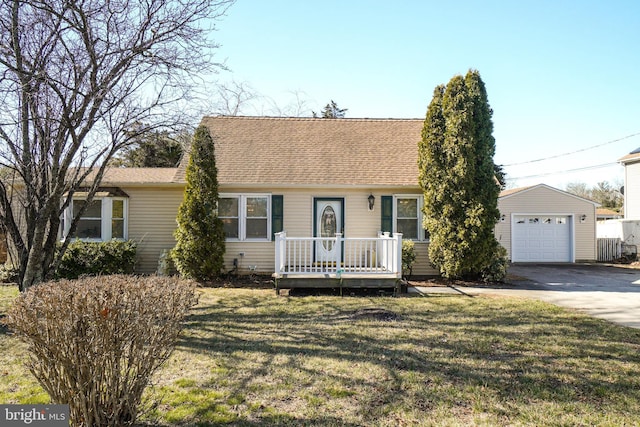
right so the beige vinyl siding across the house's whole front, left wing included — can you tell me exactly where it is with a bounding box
[123,187,436,275]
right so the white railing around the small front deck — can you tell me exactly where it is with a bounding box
[275,231,402,279]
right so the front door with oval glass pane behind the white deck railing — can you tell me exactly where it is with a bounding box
[313,198,344,261]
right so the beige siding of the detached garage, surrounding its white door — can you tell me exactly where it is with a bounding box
[495,186,596,261]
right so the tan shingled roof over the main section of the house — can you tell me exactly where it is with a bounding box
[175,116,424,187]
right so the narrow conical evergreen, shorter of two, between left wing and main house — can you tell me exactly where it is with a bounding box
[172,126,225,282]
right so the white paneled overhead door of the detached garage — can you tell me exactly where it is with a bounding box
[511,215,572,262]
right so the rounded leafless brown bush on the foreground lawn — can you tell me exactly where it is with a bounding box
[5,275,197,426]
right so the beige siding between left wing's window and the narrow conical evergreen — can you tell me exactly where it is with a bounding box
[122,187,184,273]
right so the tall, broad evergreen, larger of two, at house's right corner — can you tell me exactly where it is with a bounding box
[418,71,506,280]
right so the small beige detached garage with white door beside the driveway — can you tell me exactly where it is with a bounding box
[496,184,597,262]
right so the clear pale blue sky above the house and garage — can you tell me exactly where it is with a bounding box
[205,0,640,189]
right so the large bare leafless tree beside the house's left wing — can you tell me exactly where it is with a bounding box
[0,0,234,289]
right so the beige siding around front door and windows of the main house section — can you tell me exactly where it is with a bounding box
[220,187,437,276]
